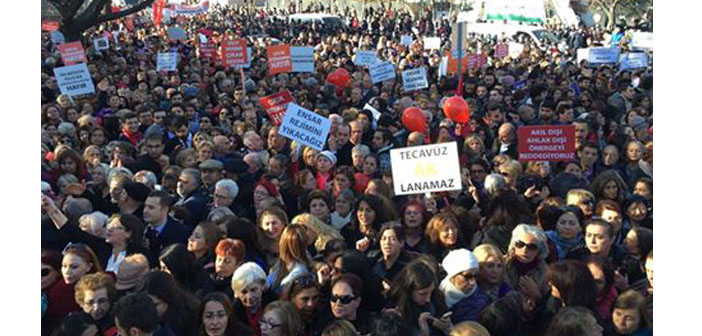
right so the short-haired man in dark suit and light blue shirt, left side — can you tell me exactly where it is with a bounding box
[144,190,191,255]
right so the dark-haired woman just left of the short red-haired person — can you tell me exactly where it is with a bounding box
[158,244,213,297]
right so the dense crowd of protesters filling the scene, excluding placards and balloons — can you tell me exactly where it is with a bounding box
[41,3,653,336]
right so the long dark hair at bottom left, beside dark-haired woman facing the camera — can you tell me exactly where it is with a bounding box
[139,271,199,335]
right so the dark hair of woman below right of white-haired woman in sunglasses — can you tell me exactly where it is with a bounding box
[546,260,597,309]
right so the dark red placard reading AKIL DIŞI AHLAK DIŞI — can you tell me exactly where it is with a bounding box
[517,125,575,161]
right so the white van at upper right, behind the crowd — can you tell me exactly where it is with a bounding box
[466,23,559,50]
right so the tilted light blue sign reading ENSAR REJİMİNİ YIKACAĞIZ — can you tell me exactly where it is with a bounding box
[278,103,331,151]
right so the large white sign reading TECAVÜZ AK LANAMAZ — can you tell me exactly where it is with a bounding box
[390,141,462,195]
